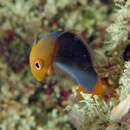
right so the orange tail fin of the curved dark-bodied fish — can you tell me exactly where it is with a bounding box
[77,78,104,100]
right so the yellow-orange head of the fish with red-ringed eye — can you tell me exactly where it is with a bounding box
[30,37,55,81]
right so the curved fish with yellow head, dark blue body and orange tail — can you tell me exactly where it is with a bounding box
[29,31,104,99]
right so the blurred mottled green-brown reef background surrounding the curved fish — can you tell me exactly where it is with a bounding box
[0,0,130,130]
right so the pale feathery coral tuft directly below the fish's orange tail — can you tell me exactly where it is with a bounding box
[69,92,116,130]
